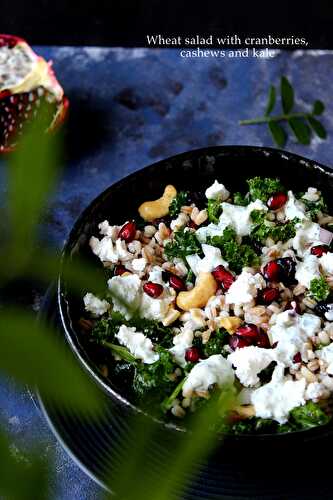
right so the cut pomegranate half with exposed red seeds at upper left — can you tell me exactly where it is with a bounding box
[0,34,69,153]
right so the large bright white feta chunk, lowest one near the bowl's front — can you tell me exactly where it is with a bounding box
[251,365,306,424]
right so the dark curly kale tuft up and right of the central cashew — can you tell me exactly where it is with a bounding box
[207,227,259,274]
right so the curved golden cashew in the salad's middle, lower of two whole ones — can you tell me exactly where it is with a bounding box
[177,272,217,311]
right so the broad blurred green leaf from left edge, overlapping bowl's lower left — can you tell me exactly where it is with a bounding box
[0,309,102,414]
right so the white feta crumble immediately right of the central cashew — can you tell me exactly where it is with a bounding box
[225,271,266,306]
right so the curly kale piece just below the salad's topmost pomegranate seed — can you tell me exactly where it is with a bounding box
[251,210,299,242]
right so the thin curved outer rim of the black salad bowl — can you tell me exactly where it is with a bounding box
[56,145,333,442]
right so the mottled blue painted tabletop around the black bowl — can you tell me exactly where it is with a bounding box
[0,47,333,500]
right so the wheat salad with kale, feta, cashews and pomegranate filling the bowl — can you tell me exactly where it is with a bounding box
[79,176,333,434]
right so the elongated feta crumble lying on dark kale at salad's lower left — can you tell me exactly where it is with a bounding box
[115,325,159,365]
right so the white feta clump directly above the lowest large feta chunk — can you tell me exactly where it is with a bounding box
[268,310,321,367]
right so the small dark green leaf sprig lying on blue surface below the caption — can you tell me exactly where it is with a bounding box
[239,76,327,148]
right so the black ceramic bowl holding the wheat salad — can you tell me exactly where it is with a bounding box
[58,146,333,442]
